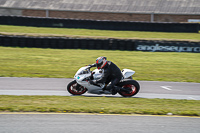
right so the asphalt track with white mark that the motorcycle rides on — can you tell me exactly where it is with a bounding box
[0,77,200,100]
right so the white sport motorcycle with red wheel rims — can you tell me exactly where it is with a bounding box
[67,66,140,97]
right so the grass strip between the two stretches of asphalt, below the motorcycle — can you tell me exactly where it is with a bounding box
[0,95,200,116]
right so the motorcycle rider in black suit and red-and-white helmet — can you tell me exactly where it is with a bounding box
[89,56,122,95]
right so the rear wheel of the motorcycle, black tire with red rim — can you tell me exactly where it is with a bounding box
[118,79,140,97]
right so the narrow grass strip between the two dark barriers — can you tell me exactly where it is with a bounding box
[0,25,200,41]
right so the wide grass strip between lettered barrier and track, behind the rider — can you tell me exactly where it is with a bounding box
[0,47,200,83]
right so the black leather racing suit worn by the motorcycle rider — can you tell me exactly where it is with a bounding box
[94,61,122,90]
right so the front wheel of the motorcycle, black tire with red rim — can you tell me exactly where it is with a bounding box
[67,80,87,95]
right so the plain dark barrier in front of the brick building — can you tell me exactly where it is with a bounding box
[0,16,200,33]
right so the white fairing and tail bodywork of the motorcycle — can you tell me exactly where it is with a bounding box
[74,66,135,94]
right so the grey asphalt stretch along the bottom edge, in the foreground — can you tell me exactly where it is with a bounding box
[0,113,200,133]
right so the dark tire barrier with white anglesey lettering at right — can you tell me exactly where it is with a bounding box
[0,35,200,53]
